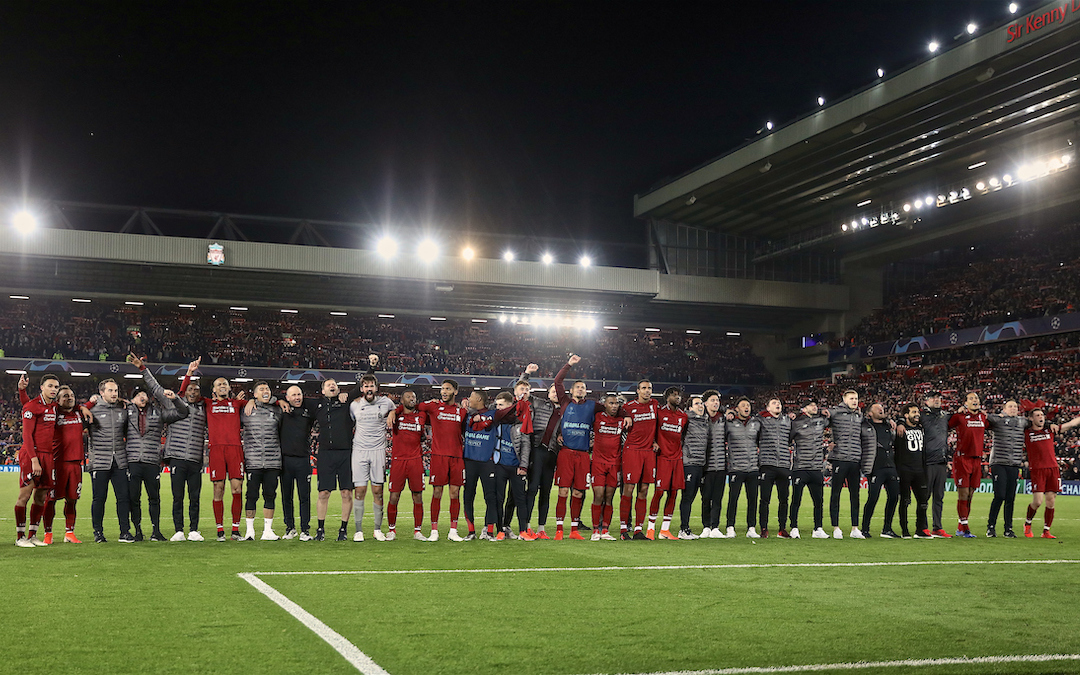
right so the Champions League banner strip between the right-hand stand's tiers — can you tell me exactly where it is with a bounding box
[828,312,1080,363]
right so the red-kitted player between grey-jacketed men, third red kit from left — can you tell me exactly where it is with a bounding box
[180,356,244,541]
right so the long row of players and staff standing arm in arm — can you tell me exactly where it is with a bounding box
[15,354,1080,548]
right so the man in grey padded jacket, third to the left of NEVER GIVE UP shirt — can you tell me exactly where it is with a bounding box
[789,399,828,539]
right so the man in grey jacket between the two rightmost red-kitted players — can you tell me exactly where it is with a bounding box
[986,399,1031,539]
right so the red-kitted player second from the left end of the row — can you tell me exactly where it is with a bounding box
[18,375,86,544]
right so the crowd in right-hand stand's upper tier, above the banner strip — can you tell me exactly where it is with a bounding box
[845,225,1080,345]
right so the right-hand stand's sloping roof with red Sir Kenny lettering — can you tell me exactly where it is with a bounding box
[634,2,1080,258]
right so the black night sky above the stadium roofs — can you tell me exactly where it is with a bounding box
[0,0,1010,262]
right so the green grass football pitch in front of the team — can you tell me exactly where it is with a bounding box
[0,474,1080,675]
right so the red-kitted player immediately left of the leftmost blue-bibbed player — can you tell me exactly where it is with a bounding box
[417,380,469,541]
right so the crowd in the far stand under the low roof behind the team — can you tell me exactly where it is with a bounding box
[0,298,771,384]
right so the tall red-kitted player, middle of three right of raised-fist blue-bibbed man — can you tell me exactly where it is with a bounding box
[619,380,660,539]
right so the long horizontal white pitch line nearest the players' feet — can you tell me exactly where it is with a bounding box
[251,559,1080,577]
